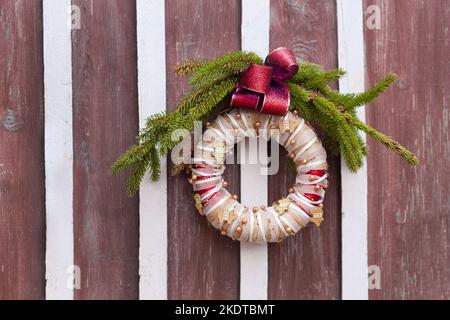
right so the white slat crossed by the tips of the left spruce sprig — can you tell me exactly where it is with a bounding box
[136,0,167,300]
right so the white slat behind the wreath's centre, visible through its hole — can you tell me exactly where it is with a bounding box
[240,0,270,300]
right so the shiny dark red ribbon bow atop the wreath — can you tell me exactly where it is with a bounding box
[231,47,298,116]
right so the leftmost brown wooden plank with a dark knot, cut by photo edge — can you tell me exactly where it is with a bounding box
[0,0,45,299]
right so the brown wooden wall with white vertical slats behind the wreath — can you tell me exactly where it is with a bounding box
[0,0,450,299]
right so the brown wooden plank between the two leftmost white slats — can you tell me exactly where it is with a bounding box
[72,0,139,299]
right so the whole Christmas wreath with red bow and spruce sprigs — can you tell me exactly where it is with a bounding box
[113,48,418,242]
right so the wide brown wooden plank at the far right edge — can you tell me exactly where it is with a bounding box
[365,0,450,299]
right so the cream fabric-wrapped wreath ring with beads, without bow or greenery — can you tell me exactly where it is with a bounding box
[191,109,328,243]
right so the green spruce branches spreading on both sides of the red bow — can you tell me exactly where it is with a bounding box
[112,51,418,196]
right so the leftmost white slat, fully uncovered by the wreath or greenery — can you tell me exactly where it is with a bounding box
[43,0,74,300]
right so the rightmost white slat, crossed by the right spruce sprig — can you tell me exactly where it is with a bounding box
[337,0,368,299]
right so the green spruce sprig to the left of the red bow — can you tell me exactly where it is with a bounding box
[112,51,262,196]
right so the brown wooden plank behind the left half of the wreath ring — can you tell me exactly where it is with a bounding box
[166,0,240,299]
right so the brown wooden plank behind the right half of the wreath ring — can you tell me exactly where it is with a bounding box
[269,0,341,299]
